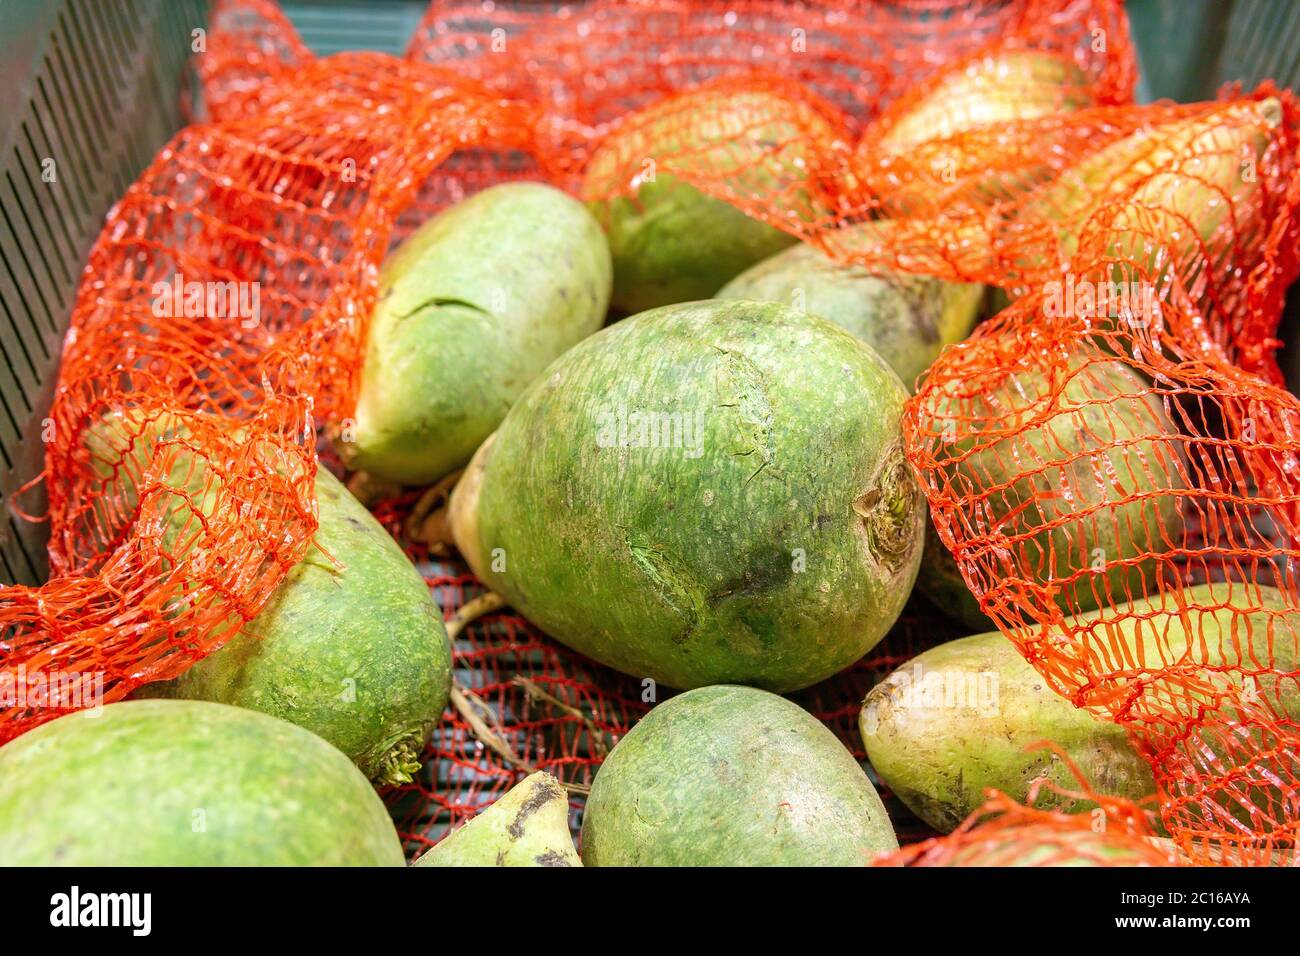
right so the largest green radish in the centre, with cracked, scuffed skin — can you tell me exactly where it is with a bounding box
[467,300,926,691]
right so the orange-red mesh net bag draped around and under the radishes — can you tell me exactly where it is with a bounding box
[0,0,1300,864]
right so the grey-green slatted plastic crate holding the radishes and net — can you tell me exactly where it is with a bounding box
[0,0,1300,849]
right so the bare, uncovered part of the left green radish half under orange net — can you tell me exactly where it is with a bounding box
[146,470,451,786]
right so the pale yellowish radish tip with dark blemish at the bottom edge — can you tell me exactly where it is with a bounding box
[412,773,582,866]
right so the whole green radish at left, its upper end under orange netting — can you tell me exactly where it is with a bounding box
[83,411,451,786]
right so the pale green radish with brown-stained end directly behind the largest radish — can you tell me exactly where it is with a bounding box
[716,224,984,388]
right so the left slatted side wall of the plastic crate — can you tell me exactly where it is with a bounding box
[0,0,207,584]
